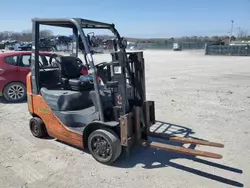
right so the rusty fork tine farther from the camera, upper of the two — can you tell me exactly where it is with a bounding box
[149,132,224,148]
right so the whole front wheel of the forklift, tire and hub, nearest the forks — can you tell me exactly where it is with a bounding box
[88,128,122,165]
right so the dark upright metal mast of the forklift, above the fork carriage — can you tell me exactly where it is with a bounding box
[107,51,146,117]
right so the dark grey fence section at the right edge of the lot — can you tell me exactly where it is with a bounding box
[205,45,250,56]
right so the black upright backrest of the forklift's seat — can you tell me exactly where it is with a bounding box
[57,56,81,79]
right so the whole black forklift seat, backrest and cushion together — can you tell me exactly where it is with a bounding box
[56,56,94,91]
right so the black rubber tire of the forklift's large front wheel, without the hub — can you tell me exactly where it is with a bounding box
[88,128,122,165]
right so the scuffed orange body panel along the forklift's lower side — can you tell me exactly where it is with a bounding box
[27,73,83,148]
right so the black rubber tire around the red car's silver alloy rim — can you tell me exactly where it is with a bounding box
[3,82,27,103]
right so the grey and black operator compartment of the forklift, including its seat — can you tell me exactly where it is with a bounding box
[40,56,112,131]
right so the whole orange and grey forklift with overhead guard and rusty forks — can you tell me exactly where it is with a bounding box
[27,18,224,164]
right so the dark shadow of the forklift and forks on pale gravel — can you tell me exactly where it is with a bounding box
[113,122,243,187]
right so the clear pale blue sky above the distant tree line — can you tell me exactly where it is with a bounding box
[0,0,250,38]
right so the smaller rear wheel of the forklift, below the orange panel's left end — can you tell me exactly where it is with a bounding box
[29,117,48,138]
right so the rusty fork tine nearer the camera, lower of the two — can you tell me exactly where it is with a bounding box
[141,141,222,159]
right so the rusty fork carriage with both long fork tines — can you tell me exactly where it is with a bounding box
[120,101,224,159]
